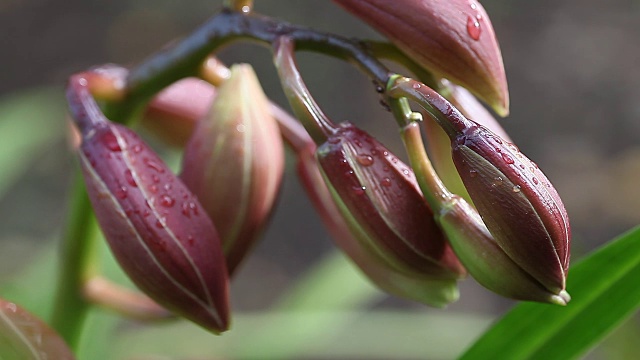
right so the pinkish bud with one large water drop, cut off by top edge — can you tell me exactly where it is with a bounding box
[334,0,509,116]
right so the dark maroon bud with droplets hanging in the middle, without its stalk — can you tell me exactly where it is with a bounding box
[317,123,465,279]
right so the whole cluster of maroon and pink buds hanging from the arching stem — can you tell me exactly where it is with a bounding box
[67,0,571,333]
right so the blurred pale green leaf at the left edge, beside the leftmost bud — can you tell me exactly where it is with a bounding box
[0,87,66,197]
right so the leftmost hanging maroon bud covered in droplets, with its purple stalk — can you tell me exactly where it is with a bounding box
[67,75,229,333]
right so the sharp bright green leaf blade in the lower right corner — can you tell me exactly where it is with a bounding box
[461,228,640,360]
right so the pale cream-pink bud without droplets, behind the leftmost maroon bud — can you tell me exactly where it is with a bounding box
[180,64,284,274]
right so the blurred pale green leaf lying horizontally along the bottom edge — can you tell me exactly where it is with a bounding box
[112,310,490,360]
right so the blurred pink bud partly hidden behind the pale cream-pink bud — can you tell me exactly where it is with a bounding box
[141,78,216,147]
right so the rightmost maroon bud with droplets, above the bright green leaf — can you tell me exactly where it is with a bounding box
[452,121,571,293]
